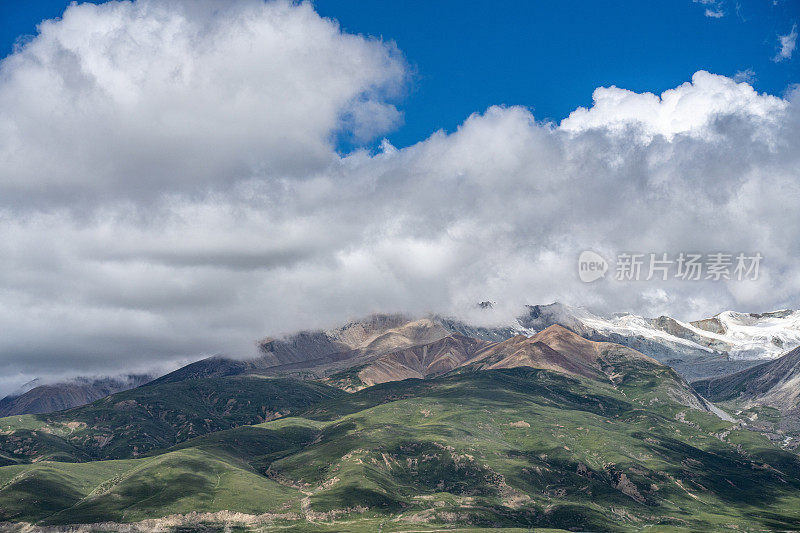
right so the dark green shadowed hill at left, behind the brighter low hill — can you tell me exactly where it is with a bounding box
[0,376,344,464]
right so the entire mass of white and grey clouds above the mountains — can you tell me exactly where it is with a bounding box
[0,2,800,387]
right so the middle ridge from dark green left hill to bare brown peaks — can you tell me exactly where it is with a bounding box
[0,320,731,462]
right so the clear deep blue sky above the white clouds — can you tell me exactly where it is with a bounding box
[0,0,800,147]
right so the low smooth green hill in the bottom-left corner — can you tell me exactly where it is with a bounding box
[0,449,298,524]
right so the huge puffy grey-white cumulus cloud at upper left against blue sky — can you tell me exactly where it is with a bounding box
[0,0,405,206]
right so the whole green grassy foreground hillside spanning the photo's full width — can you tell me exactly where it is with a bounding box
[0,368,800,531]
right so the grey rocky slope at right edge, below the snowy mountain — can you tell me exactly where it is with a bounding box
[692,348,800,448]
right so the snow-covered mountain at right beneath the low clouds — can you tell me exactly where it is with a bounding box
[519,303,800,379]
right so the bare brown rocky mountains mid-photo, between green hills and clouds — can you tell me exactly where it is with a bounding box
[144,306,724,409]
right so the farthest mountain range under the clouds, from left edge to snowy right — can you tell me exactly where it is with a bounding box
[6,303,800,415]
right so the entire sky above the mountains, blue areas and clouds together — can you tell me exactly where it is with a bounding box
[0,0,800,393]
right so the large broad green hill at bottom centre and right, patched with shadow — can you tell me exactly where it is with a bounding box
[265,369,800,530]
